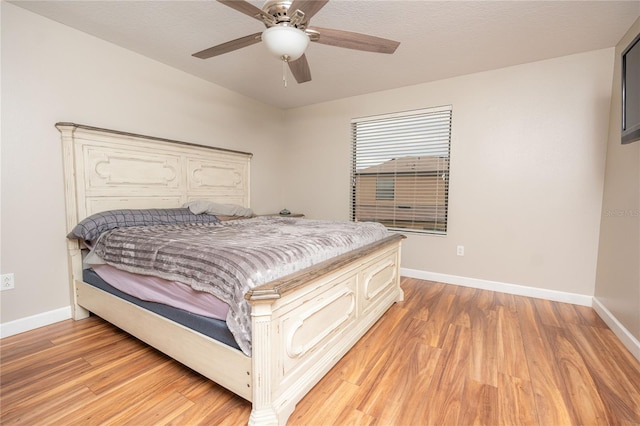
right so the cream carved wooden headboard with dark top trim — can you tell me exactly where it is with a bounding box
[56,123,251,231]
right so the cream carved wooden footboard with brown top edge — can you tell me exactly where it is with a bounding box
[247,235,403,425]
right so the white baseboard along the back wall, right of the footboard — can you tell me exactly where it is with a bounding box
[400,268,593,306]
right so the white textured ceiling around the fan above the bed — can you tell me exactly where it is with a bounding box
[11,0,640,108]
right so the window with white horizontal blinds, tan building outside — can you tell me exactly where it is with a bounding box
[351,106,452,234]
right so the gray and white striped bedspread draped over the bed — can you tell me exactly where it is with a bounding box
[94,217,388,356]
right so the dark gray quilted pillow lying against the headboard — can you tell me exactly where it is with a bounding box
[67,208,219,241]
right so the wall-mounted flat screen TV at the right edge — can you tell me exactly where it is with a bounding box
[622,35,640,143]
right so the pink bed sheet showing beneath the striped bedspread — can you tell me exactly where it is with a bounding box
[92,265,229,321]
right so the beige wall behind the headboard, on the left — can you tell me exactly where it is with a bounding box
[0,2,283,323]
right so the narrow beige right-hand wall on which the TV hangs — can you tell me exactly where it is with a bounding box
[595,19,640,340]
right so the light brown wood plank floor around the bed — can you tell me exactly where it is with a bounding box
[0,279,640,426]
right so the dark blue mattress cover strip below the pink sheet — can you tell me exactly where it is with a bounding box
[82,269,240,349]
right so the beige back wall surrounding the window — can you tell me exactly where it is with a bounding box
[285,48,613,301]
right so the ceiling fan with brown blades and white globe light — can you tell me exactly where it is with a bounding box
[192,0,400,83]
